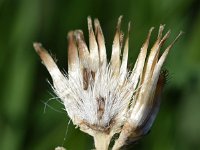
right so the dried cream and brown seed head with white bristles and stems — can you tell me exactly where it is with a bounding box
[34,16,181,150]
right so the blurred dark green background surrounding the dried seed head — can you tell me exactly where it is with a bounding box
[0,0,200,150]
